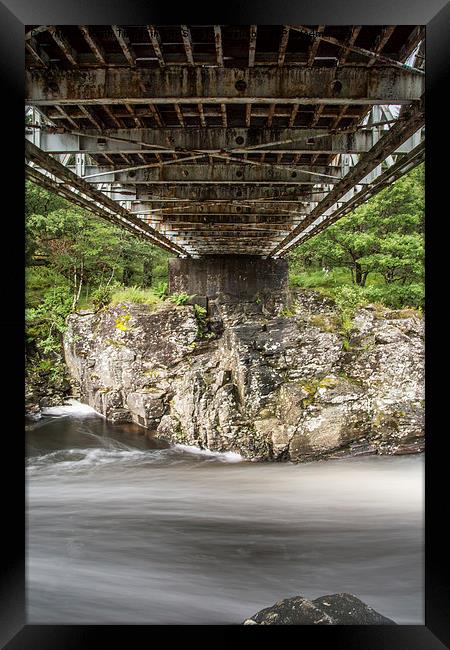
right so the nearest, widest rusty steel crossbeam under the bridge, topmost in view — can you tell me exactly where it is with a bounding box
[26,65,425,106]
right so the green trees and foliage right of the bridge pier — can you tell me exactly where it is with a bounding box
[289,165,424,308]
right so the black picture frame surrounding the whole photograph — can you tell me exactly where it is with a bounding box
[0,0,450,650]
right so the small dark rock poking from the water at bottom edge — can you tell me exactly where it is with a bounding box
[243,594,396,625]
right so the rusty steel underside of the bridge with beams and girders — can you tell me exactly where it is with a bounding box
[25,25,425,261]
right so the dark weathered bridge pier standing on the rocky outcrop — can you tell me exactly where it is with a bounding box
[169,255,288,301]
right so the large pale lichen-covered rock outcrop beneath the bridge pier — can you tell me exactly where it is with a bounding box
[64,290,424,461]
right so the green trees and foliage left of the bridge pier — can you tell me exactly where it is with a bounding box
[25,178,168,307]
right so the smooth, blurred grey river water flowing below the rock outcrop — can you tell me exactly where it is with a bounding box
[27,406,424,624]
